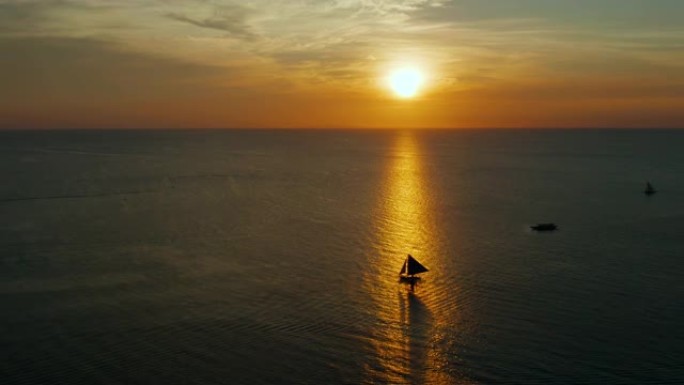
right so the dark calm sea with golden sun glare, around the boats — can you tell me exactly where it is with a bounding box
[0,131,684,385]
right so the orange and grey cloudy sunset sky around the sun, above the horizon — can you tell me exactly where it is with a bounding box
[0,0,684,129]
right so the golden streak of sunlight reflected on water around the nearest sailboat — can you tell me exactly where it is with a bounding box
[364,132,462,384]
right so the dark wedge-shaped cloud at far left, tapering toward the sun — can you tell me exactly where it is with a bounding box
[0,37,230,104]
